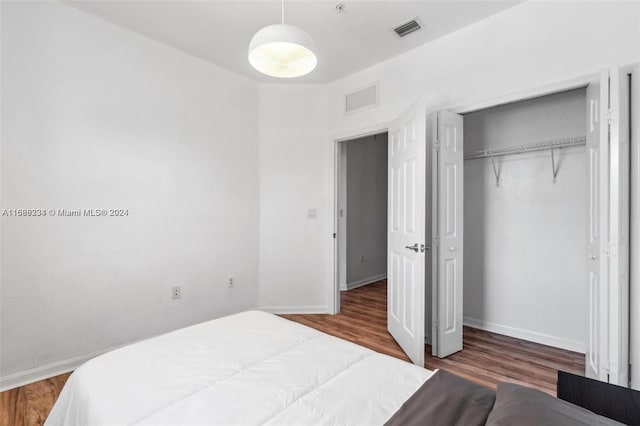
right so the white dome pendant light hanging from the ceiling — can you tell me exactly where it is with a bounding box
[249,0,318,78]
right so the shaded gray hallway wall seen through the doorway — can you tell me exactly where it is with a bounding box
[342,133,388,289]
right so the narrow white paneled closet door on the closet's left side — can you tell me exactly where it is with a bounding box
[432,111,464,358]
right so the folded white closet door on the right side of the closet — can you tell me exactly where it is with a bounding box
[585,68,629,386]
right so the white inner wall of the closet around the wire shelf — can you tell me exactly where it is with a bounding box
[464,89,588,352]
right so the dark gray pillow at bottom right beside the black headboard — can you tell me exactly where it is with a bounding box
[487,383,622,426]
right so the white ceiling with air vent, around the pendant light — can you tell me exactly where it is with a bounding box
[66,0,522,83]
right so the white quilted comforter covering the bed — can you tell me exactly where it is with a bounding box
[45,311,432,426]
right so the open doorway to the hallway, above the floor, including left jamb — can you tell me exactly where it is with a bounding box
[336,131,388,302]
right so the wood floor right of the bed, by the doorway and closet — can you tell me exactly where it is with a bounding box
[283,281,584,396]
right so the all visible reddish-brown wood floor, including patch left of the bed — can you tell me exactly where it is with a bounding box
[0,281,584,426]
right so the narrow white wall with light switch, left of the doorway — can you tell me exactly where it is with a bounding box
[259,85,334,312]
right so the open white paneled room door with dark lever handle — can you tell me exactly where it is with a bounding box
[387,105,426,367]
